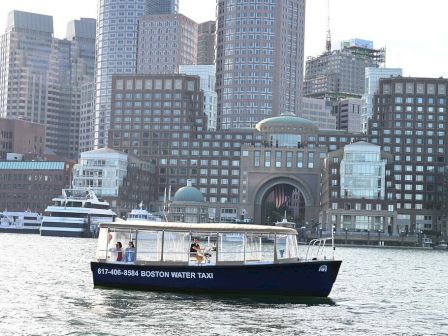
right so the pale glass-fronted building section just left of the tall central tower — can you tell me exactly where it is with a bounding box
[179,65,218,130]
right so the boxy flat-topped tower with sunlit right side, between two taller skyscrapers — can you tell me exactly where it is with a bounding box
[137,14,198,74]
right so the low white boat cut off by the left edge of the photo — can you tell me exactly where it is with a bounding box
[0,211,42,234]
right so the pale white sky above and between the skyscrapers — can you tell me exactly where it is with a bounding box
[0,0,448,78]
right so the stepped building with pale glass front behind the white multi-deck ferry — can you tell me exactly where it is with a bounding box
[72,148,155,217]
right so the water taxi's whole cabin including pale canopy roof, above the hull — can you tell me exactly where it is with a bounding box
[96,222,299,266]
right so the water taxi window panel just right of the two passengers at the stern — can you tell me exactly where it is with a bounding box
[136,231,162,263]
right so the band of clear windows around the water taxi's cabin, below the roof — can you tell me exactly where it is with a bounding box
[96,227,299,265]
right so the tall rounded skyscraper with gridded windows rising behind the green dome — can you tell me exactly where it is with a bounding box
[216,0,305,129]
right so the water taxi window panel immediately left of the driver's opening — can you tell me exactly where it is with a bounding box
[163,232,190,262]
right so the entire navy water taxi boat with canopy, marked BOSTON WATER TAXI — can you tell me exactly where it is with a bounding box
[91,221,341,297]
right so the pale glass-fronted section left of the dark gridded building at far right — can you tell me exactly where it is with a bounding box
[361,67,403,133]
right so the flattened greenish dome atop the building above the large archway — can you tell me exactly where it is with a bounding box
[255,113,318,133]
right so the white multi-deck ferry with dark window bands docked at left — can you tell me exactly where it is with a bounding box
[40,189,116,238]
